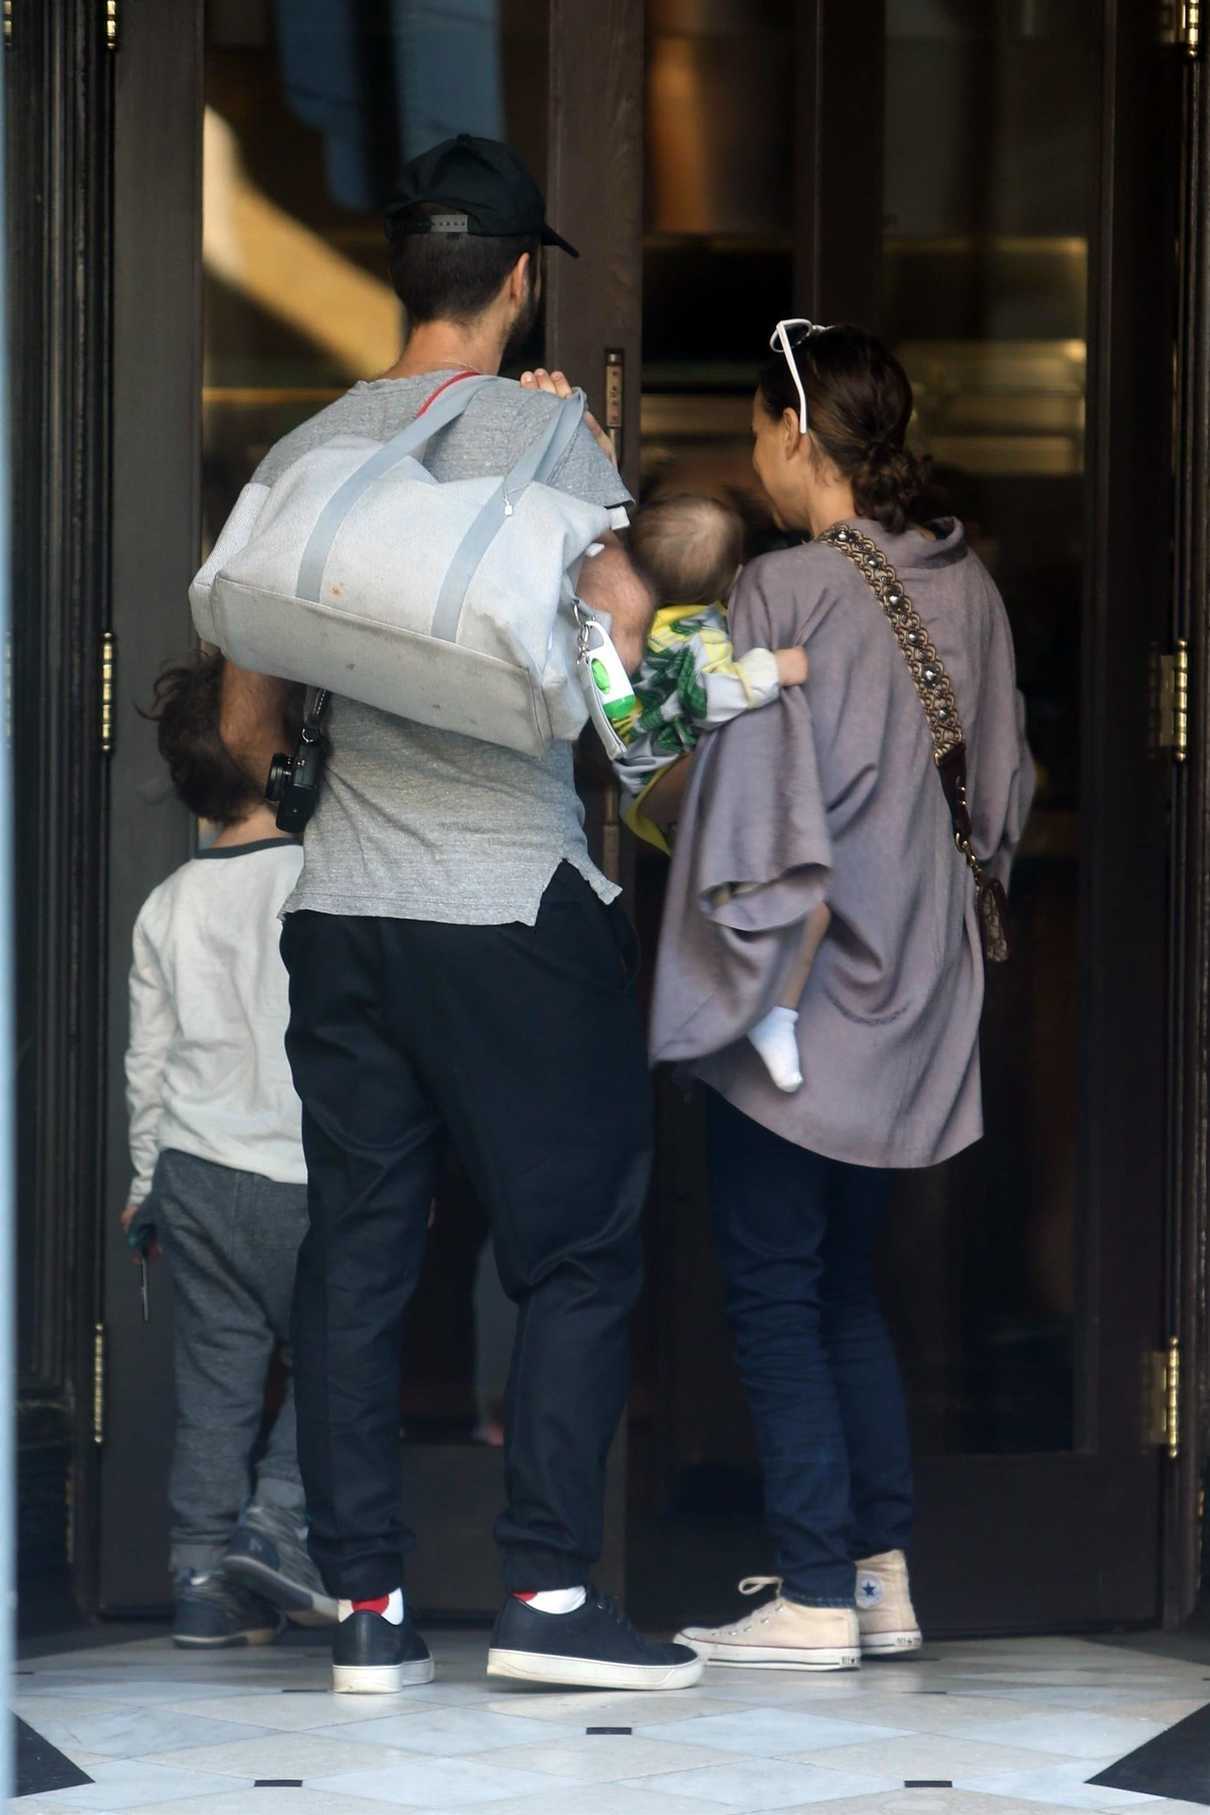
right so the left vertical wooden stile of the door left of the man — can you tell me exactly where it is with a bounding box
[100,0,203,1612]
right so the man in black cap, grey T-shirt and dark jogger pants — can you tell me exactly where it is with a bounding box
[223,136,700,1692]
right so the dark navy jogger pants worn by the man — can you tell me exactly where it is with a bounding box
[281,864,651,1599]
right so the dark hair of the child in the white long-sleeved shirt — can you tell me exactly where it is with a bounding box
[149,650,270,826]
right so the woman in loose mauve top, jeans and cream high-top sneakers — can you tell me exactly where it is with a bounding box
[653,323,1032,1670]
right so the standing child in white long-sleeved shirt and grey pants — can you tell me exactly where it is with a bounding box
[122,657,336,1646]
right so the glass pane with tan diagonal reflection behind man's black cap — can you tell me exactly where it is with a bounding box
[203,0,548,545]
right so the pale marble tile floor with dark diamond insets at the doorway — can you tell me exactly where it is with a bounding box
[9,1632,1210,1815]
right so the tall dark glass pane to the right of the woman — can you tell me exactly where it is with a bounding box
[883,0,1099,1452]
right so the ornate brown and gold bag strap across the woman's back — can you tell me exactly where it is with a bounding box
[818,523,1009,964]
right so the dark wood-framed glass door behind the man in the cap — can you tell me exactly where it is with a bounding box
[102,0,640,1614]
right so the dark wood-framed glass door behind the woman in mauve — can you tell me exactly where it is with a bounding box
[631,0,1177,1630]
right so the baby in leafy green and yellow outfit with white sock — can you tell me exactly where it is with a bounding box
[615,495,831,1091]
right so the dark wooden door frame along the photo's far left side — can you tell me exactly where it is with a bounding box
[4,0,112,1608]
